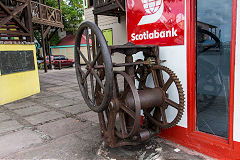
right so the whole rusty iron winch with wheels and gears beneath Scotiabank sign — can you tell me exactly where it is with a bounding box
[75,22,184,147]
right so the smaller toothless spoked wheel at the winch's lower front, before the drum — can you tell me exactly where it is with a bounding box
[114,71,141,139]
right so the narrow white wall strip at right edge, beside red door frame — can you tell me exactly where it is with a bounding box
[233,0,240,142]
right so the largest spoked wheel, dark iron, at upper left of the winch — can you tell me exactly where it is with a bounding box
[74,21,113,112]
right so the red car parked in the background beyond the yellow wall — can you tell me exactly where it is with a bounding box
[42,55,74,68]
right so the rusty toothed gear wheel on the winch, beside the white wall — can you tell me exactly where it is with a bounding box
[139,65,184,129]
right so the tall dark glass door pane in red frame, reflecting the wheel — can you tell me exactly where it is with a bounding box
[196,0,232,138]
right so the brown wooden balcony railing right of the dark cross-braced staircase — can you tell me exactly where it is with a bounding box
[31,1,63,28]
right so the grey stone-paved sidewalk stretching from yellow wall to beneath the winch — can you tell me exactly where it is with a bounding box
[0,68,210,160]
